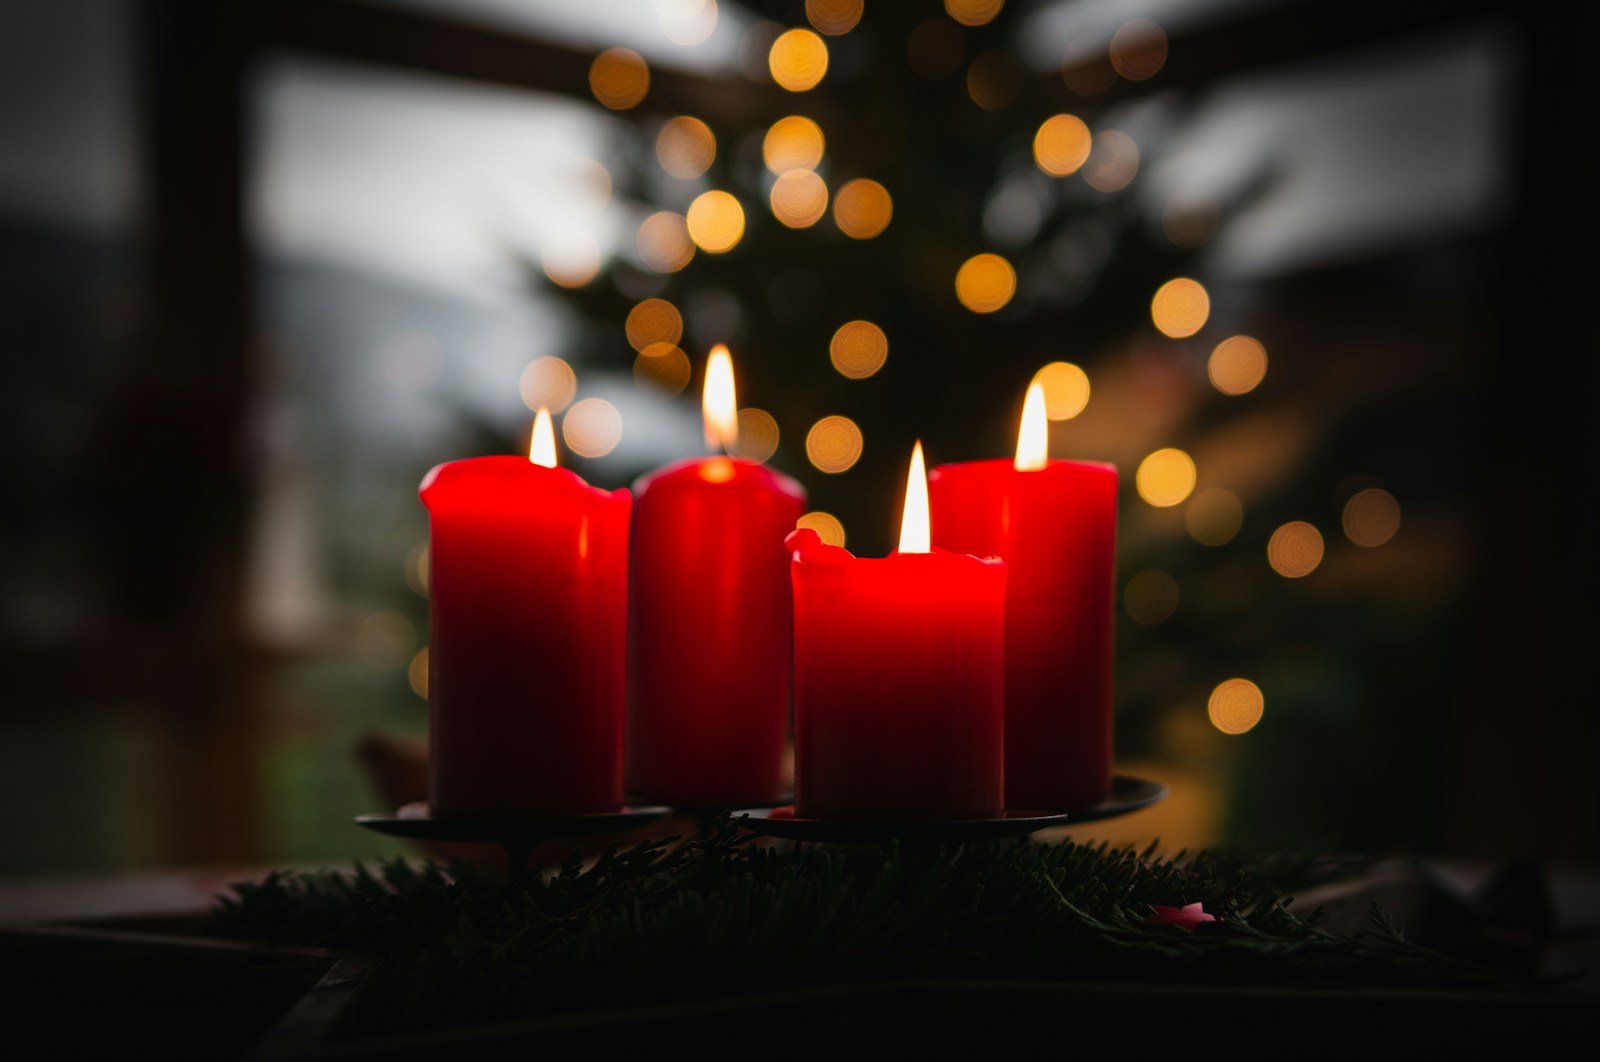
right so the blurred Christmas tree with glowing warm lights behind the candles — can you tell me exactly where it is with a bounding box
[525,0,1452,841]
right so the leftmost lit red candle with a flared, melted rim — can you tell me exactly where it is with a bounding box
[421,409,630,816]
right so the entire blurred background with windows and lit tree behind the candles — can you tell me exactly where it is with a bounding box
[0,0,1600,875]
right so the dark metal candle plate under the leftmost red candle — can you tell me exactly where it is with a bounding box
[355,801,672,880]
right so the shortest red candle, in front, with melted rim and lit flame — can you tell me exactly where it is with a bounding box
[789,443,1006,819]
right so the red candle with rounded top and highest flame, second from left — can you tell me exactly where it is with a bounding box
[627,345,805,808]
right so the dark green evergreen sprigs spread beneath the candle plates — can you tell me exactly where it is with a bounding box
[211,824,1491,1028]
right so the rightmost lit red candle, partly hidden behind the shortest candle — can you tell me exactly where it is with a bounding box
[930,382,1117,809]
